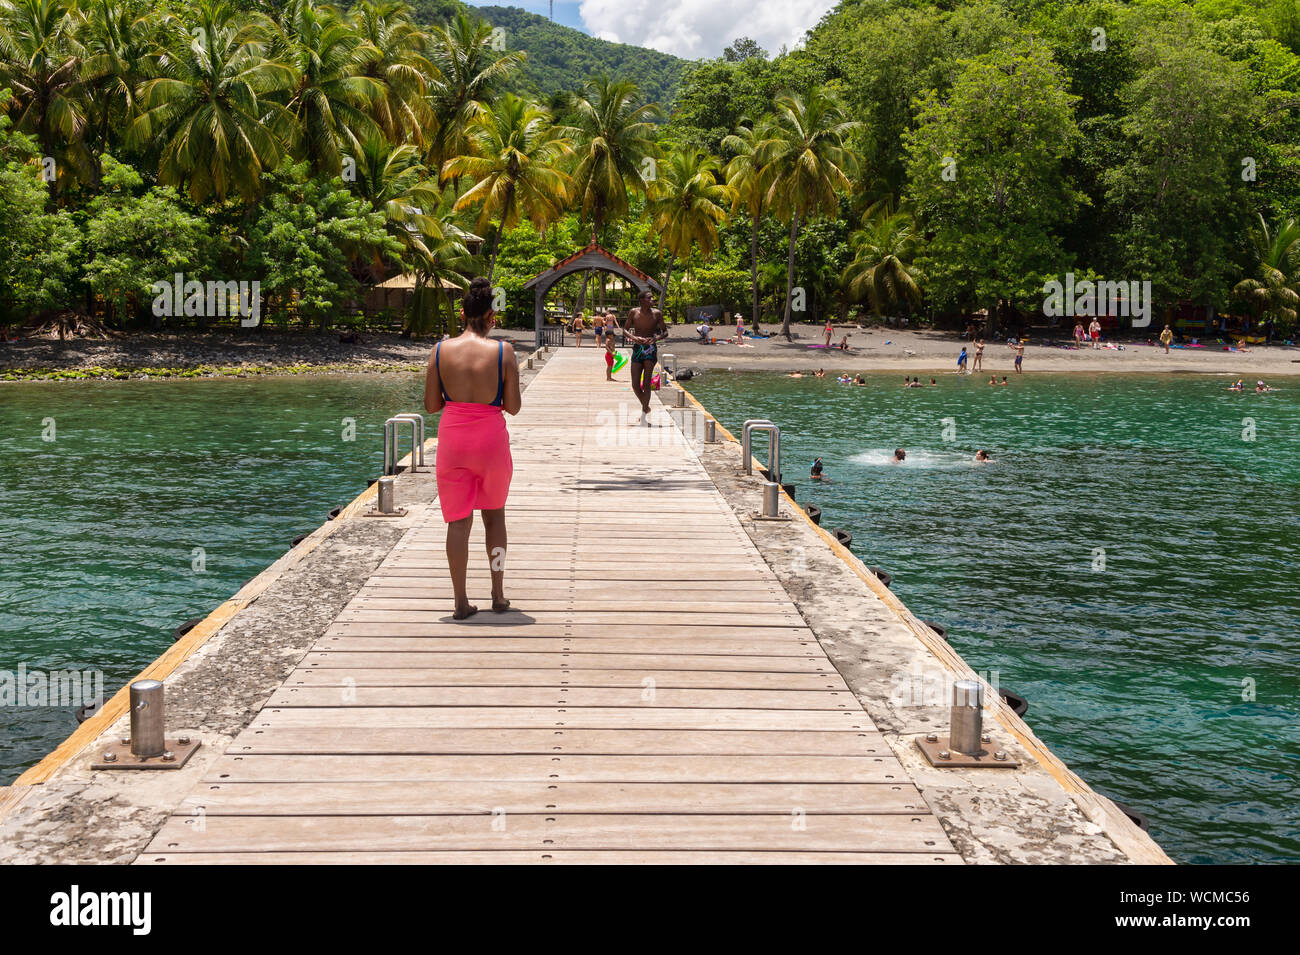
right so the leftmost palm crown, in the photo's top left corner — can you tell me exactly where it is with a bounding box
[0,0,88,184]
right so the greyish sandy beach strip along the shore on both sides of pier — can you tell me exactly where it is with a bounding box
[0,325,1300,385]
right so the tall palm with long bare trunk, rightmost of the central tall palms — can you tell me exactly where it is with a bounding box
[757,87,861,340]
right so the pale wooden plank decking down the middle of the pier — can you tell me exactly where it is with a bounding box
[139,348,961,864]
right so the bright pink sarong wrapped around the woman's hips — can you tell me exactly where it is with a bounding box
[434,401,515,524]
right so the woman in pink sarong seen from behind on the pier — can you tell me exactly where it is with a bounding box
[424,278,521,620]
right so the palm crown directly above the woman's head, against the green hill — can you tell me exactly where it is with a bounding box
[426,13,524,179]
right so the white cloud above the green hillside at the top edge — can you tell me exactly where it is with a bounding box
[579,0,836,60]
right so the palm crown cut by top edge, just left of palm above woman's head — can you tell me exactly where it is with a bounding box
[351,0,442,146]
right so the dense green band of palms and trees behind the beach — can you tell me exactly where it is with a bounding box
[0,0,1300,348]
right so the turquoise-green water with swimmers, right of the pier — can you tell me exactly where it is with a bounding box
[690,372,1300,863]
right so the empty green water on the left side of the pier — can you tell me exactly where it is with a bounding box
[0,374,424,783]
